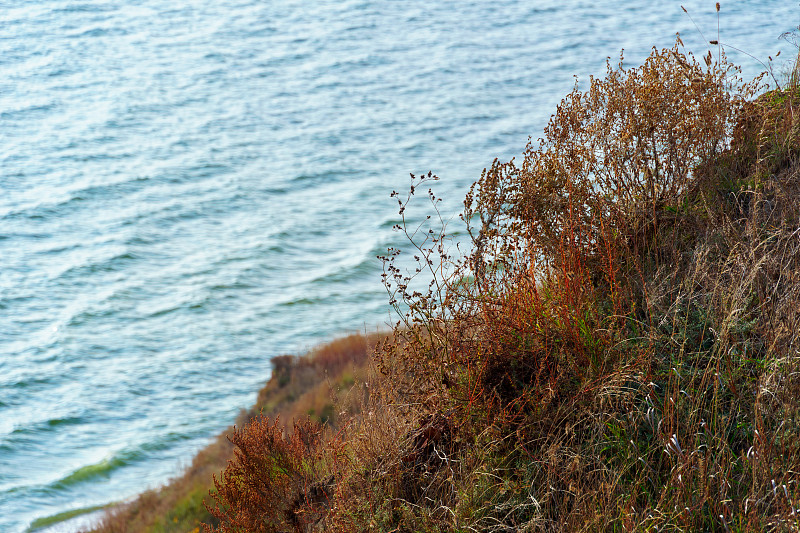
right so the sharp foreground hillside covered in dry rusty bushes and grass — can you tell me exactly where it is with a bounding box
[92,43,800,533]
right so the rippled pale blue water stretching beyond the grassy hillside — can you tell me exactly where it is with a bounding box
[0,0,800,533]
